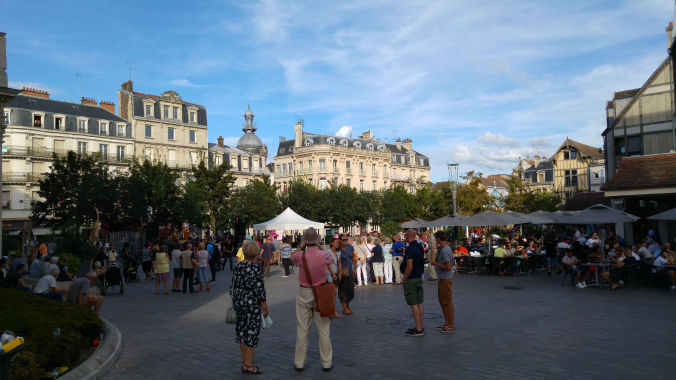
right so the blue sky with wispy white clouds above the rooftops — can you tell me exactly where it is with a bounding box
[0,0,674,182]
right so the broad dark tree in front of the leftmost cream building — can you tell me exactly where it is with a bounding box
[32,151,118,229]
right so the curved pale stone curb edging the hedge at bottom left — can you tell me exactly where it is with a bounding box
[59,318,122,380]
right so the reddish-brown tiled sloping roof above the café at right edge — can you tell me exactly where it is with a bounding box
[601,153,676,191]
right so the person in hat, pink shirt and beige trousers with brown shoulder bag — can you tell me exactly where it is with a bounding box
[293,228,335,372]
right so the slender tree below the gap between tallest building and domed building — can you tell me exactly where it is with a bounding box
[191,160,234,231]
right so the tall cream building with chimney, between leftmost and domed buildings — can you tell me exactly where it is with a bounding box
[118,81,208,171]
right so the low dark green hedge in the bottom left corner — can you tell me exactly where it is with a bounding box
[0,288,103,378]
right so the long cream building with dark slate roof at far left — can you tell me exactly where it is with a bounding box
[2,88,134,221]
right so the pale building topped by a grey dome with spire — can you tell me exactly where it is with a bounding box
[209,108,270,187]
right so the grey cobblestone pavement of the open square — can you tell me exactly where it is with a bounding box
[102,267,676,380]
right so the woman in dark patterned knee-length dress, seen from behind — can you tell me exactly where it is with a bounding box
[232,242,268,374]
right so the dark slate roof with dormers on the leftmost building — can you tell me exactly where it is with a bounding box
[5,95,127,123]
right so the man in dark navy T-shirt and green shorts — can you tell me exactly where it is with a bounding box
[401,229,425,336]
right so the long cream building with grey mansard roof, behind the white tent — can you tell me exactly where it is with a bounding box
[274,121,430,192]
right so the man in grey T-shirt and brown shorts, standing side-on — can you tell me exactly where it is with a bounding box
[430,231,455,333]
